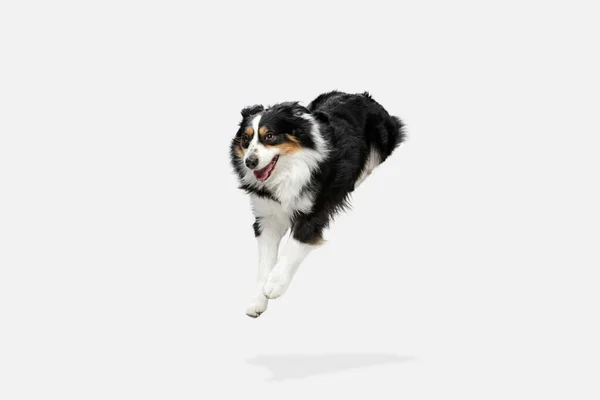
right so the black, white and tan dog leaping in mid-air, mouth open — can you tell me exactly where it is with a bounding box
[230,90,405,318]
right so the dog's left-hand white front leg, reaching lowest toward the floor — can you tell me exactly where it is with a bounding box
[246,216,289,318]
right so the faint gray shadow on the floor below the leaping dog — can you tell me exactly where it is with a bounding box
[246,353,413,382]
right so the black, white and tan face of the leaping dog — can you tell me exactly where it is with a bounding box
[232,103,314,182]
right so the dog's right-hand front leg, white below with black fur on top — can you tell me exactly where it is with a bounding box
[263,214,327,299]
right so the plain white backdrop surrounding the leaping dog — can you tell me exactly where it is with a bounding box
[0,1,600,400]
